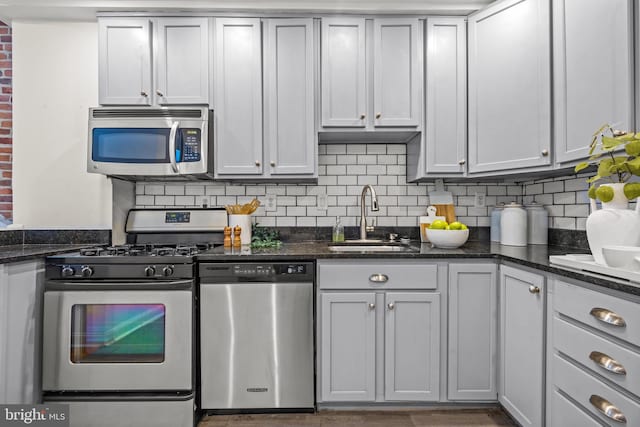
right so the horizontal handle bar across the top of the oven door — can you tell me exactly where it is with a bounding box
[44,279,195,292]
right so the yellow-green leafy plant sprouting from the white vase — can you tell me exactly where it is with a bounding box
[575,124,640,202]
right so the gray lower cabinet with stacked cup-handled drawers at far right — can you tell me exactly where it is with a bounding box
[547,278,640,426]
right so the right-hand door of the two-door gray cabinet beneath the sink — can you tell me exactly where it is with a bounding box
[384,292,440,401]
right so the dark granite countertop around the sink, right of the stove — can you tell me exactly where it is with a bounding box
[197,241,640,296]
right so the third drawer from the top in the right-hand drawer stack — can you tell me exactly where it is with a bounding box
[553,354,640,426]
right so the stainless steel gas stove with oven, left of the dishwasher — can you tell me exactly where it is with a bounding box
[42,209,227,427]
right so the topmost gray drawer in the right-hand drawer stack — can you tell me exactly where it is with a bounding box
[554,281,640,345]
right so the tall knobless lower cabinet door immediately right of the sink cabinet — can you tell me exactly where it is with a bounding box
[448,264,498,401]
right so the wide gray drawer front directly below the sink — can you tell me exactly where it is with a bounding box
[318,260,438,289]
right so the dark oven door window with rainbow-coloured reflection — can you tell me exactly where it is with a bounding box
[71,304,166,363]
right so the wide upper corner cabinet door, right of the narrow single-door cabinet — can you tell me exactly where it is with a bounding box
[469,0,551,173]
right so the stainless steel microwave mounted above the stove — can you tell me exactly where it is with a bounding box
[87,107,213,179]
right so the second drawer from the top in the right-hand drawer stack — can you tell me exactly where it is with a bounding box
[553,317,640,396]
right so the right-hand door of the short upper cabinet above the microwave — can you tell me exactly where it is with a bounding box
[155,18,210,104]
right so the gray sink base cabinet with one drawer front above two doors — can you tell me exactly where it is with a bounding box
[318,260,440,403]
